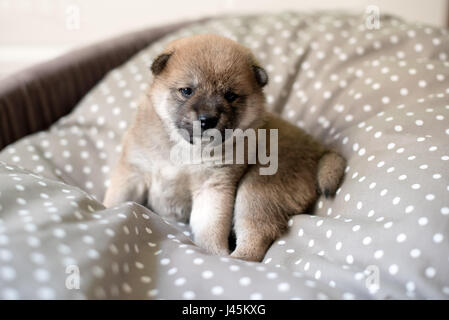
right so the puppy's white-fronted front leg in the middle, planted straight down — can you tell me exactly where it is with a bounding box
[190,186,235,255]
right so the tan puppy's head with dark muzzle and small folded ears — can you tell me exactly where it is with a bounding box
[149,35,268,142]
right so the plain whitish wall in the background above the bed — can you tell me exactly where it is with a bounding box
[0,0,449,78]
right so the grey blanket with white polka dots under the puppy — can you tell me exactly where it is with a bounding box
[0,12,449,299]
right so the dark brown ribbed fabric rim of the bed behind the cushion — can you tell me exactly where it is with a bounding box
[0,19,201,149]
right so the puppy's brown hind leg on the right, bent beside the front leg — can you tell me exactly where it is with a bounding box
[231,157,318,261]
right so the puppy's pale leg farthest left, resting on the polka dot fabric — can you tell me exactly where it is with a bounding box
[103,160,147,208]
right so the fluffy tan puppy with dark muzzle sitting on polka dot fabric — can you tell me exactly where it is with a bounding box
[104,35,346,261]
